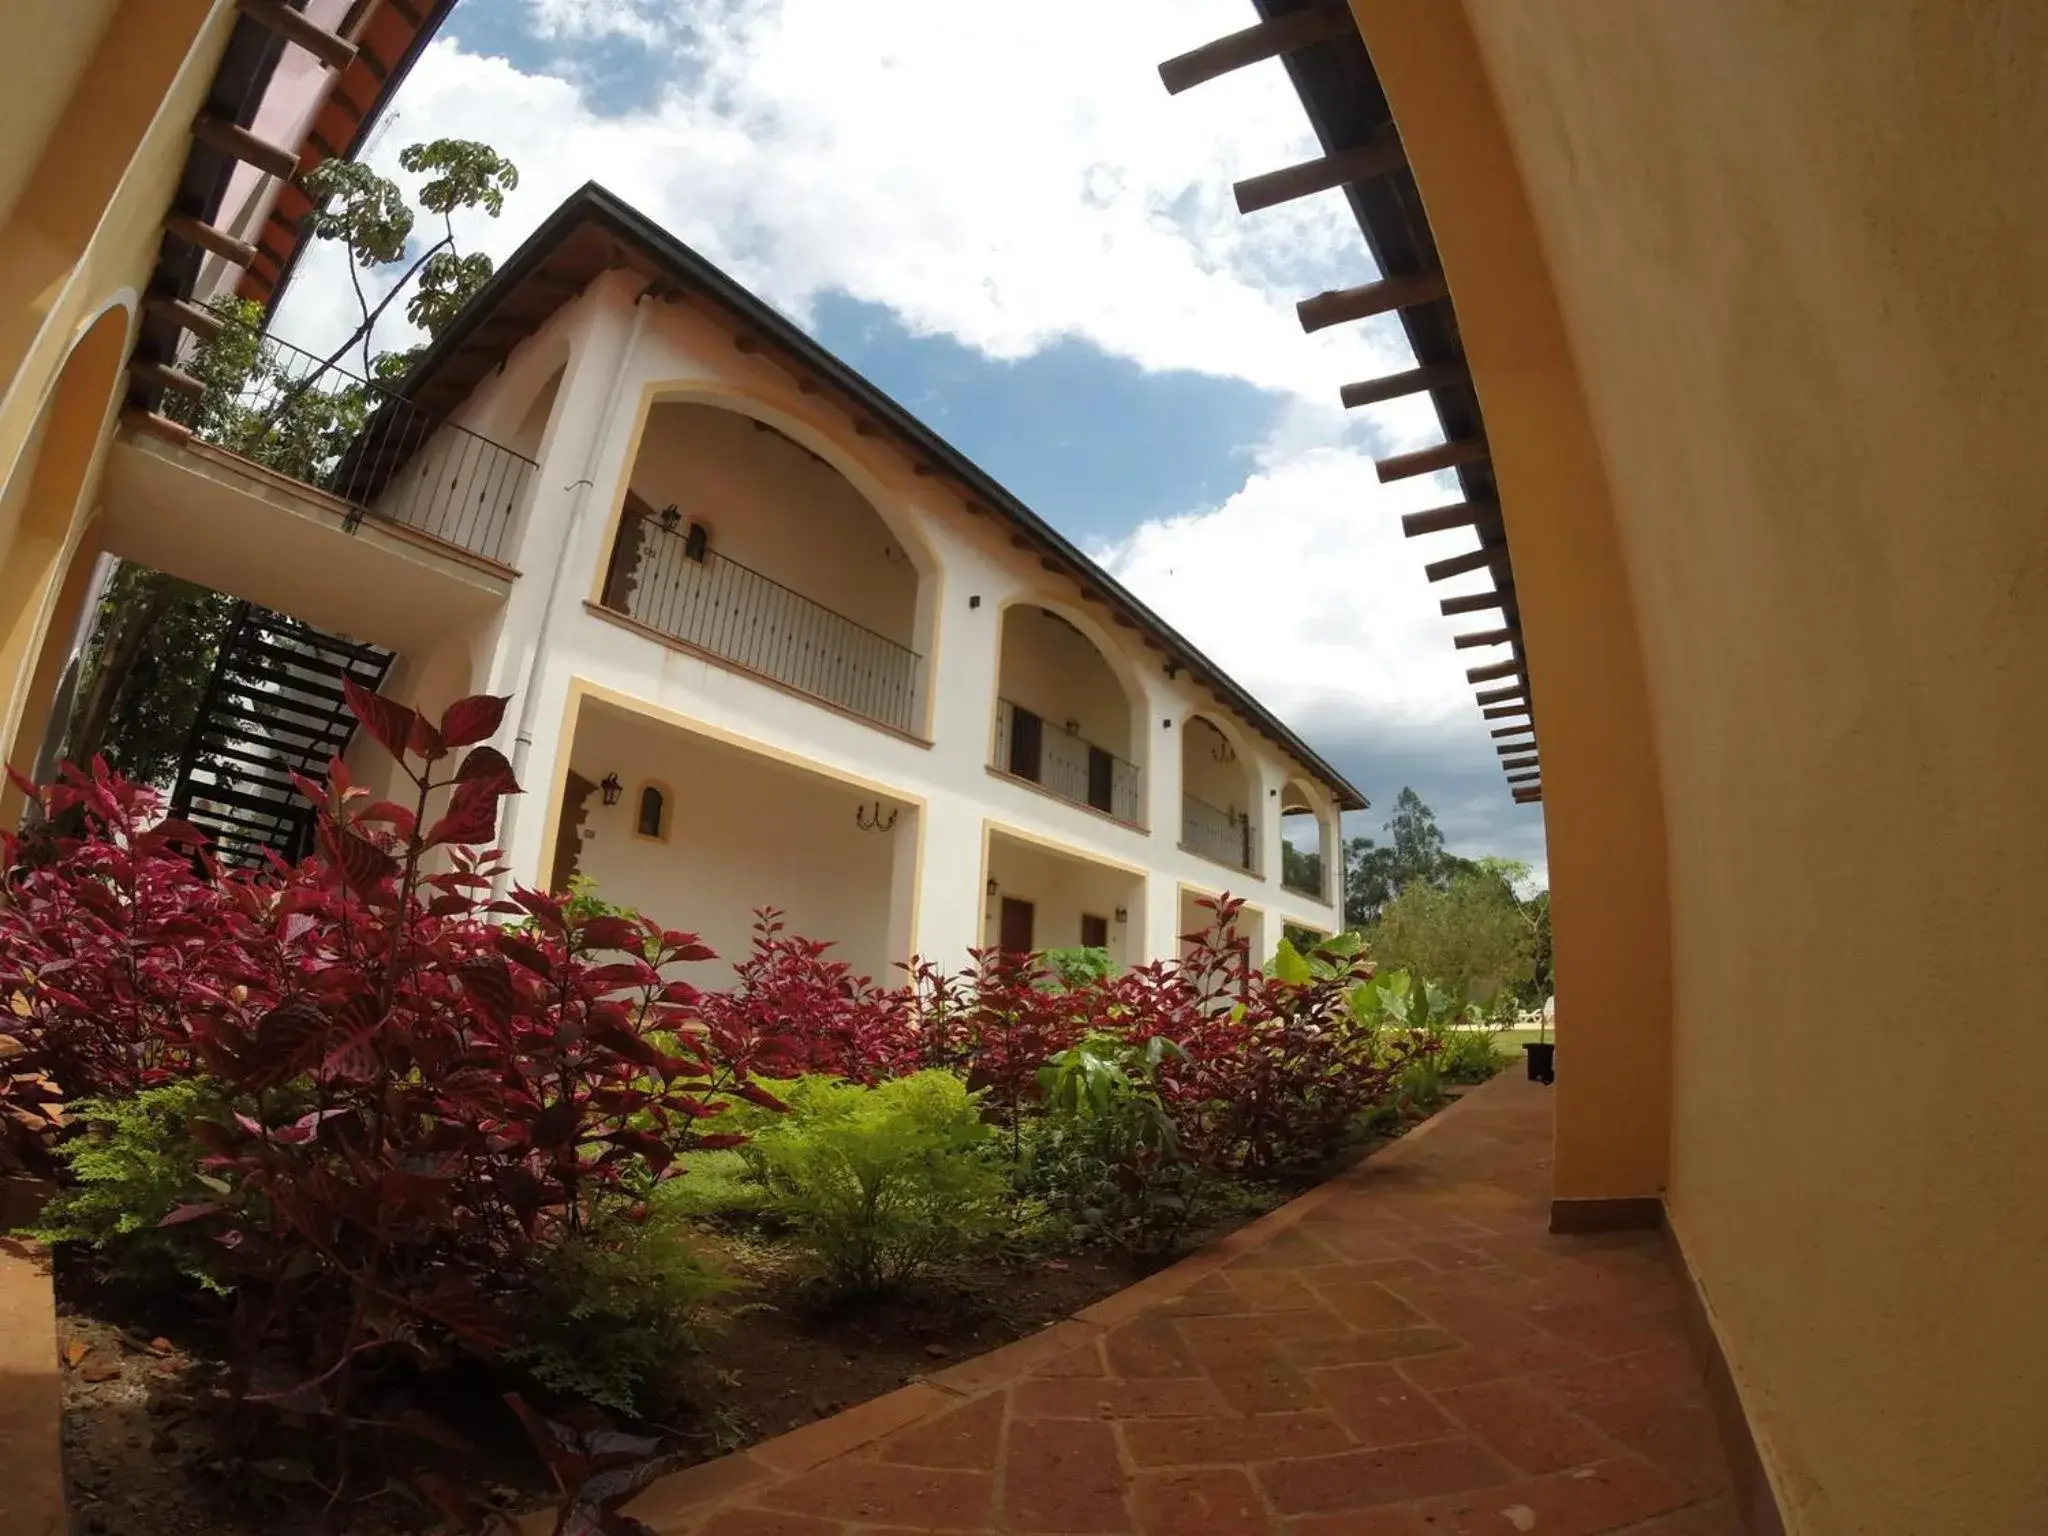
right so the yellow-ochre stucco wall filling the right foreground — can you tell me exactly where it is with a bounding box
[1354,0,2048,1536]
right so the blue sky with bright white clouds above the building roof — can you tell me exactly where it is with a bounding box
[276,0,1544,879]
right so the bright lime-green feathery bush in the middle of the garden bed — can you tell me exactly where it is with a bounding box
[749,1071,1006,1294]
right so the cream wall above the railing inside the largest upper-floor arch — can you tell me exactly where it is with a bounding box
[633,403,920,649]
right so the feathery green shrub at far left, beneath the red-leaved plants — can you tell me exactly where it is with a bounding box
[29,1077,225,1290]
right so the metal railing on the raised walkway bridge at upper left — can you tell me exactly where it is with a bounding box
[164,324,535,561]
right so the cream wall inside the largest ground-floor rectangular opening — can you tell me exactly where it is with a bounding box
[569,705,918,985]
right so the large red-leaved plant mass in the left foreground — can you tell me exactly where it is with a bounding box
[0,684,778,1531]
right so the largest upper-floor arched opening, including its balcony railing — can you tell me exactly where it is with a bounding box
[600,399,932,733]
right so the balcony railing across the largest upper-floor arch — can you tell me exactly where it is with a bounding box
[604,508,924,733]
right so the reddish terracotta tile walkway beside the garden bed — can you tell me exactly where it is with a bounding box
[629,1077,1741,1536]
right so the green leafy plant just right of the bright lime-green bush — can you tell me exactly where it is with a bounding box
[1016,1034,1206,1253]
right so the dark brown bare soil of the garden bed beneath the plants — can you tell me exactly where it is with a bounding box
[44,1090,1456,1536]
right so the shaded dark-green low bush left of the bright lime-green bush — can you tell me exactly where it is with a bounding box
[508,1212,733,1415]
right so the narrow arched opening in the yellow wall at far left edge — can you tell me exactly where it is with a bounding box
[0,307,129,821]
